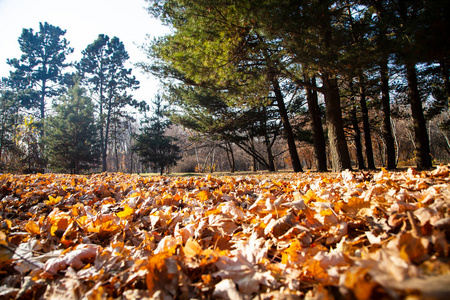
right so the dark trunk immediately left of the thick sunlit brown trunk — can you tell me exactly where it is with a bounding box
[305,76,327,172]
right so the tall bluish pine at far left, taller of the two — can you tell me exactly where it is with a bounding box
[7,22,73,123]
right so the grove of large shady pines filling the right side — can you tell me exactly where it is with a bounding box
[141,0,450,171]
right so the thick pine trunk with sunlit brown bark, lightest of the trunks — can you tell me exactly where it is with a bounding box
[322,72,352,172]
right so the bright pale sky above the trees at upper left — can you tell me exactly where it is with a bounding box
[0,0,168,101]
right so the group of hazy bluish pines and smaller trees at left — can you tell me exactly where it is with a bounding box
[0,23,172,174]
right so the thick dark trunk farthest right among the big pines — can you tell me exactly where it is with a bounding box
[406,62,432,169]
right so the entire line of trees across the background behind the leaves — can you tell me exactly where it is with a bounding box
[0,0,450,173]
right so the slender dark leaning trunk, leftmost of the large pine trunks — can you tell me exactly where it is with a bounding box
[272,78,303,172]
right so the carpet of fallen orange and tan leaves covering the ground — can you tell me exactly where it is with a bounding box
[0,166,450,299]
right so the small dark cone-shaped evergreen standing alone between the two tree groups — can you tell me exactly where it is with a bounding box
[133,95,181,175]
